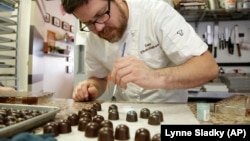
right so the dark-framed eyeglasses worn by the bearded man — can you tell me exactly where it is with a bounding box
[80,0,110,32]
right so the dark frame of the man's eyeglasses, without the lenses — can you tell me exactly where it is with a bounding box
[79,0,111,32]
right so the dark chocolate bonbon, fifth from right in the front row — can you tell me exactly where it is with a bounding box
[85,121,100,138]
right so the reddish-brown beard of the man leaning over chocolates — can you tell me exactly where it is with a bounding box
[98,3,128,43]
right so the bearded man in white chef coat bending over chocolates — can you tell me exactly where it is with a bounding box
[62,0,218,102]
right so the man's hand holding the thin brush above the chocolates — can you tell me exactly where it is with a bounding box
[111,56,157,89]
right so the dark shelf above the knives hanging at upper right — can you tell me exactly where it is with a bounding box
[179,9,250,22]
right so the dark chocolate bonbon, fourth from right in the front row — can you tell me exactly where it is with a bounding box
[98,127,114,141]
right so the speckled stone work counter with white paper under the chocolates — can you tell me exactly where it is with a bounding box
[1,95,250,140]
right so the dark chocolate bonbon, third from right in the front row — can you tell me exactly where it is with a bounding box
[115,124,130,140]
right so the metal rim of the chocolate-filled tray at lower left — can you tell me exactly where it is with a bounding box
[0,104,60,138]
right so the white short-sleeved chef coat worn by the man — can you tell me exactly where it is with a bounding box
[85,0,207,103]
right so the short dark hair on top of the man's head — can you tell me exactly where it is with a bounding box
[61,0,89,14]
